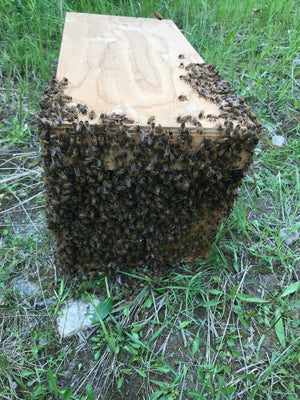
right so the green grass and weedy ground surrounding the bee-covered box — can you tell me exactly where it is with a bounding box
[0,0,300,400]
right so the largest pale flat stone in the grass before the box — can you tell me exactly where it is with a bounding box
[57,299,99,337]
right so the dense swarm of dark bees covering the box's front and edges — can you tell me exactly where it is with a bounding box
[36,64,261,282]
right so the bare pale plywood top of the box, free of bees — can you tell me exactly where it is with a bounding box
[57,13,219,130]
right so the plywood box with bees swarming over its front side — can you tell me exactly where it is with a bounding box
[38,13,261,276]
